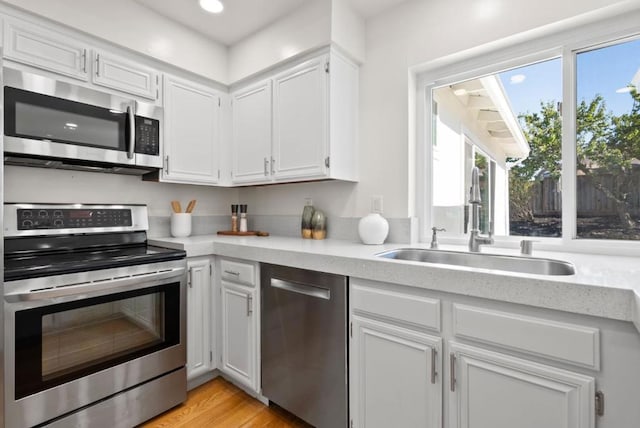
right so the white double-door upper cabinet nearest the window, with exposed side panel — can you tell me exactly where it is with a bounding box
[232,51,358,184]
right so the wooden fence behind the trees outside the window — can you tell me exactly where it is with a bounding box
[531,172,640,217]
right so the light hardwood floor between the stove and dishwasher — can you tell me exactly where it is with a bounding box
[142,377,309,428]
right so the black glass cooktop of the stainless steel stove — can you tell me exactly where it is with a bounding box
[4,233,186,281]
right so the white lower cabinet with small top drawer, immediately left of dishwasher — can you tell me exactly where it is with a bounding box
[220,259,260,392]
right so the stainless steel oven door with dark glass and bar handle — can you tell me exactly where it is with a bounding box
[5,260,186,427]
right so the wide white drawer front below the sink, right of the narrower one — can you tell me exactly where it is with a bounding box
[453,304,600,370]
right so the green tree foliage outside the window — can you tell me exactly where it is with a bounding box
[510,88,640,228]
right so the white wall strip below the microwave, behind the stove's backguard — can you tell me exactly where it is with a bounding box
[4,166,238,216]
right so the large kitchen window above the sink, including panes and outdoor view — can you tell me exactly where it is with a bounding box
[417,20,640,248]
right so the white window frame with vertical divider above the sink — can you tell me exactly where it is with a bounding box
[414,10,640,255]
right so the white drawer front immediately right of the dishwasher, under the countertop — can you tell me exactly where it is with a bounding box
[350,283,440,331]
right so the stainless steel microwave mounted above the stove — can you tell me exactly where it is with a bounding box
[3,67,163,174]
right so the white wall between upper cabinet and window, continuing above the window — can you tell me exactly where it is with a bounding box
[353,0,638,217]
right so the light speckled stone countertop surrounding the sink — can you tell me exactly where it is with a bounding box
[149,235,640,331]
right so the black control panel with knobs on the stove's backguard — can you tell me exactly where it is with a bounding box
[17,208,132,230]
